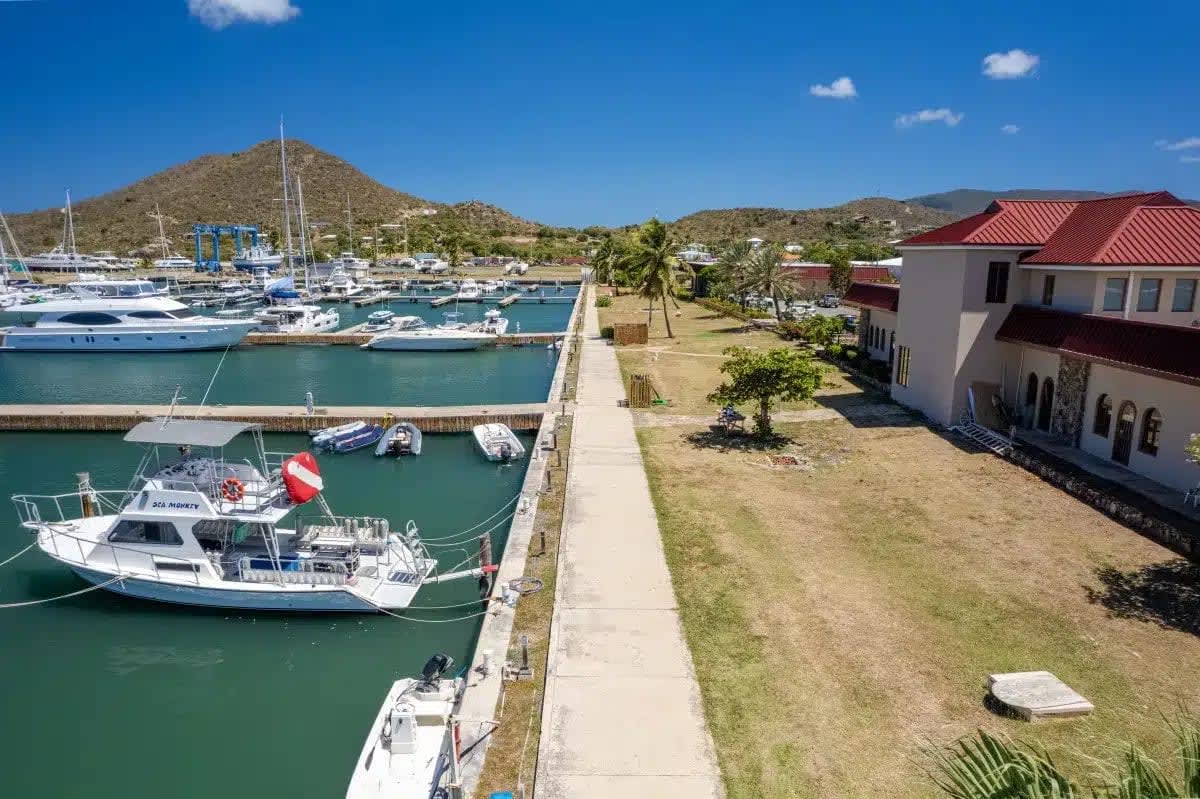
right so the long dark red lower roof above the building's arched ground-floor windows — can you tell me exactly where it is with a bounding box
[996,305,1200,385]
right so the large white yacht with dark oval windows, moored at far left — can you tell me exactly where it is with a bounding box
[0,280,257,352]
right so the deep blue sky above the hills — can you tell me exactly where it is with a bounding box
[0,0,1200,226]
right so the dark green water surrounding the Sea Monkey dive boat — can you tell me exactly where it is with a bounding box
[0,433,530,799]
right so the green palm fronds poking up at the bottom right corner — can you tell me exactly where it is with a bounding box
[926,716,1200,799]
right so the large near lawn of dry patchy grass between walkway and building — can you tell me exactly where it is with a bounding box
[640,421,1200,799]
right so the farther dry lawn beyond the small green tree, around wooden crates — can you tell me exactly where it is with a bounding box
[599,294,857,417]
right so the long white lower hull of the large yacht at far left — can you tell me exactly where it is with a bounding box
[0,322,254,353]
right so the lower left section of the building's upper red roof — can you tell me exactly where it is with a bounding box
[900,200,1079,247]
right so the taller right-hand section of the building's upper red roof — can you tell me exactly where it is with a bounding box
[1025,192,1200,266]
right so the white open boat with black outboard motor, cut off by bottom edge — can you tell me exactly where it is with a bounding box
[346,655,462,799]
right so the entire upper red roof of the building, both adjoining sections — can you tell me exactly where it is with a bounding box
[900,192,1200,266]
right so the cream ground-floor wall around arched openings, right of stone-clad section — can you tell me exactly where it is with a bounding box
[1080,364,1200,491]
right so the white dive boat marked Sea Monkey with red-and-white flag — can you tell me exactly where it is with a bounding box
[13,417,482,612]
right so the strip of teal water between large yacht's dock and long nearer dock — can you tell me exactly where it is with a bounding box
[0,346,557,405]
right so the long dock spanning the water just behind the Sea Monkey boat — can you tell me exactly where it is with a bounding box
[0,403,557,433]
